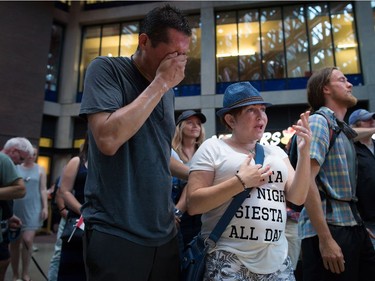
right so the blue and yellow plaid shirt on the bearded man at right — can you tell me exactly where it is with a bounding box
[299,107,357,239]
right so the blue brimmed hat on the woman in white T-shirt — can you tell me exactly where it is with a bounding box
[216,82,272,117]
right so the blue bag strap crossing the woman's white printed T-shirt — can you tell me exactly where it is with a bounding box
[209,143,264,243]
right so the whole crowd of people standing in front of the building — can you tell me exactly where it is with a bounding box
[0,4,375,281]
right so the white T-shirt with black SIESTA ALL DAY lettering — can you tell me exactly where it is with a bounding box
[190,138,288,274]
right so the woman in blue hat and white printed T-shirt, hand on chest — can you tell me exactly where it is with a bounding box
[187,82,311,280]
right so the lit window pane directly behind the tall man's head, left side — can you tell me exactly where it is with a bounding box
[120,22,139,57]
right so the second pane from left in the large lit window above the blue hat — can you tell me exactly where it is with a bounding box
[238,10,262,81]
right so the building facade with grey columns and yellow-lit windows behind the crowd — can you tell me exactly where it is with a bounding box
[0,1,375,185]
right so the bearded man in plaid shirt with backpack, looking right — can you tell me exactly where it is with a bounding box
[299,67,375,281]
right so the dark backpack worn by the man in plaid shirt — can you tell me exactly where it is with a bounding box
[287,109,341,212]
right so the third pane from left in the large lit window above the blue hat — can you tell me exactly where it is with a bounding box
[260,8,285,79]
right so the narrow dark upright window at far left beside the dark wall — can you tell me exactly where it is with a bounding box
[45,24,64,102]
